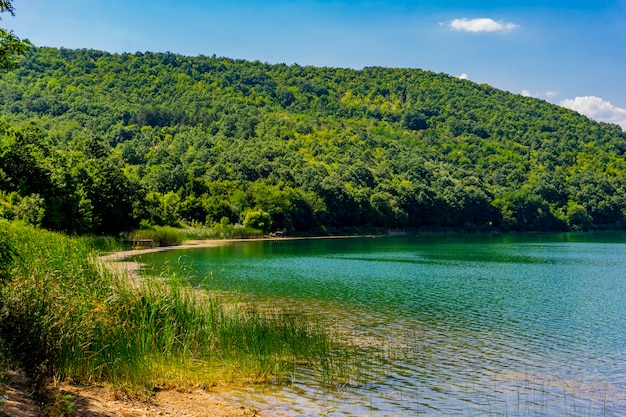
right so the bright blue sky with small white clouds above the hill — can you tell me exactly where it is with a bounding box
[0,0,626,129]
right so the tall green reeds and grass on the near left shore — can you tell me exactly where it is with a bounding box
[0,221,337,393]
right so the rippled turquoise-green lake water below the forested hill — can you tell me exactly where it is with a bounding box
[140,232,626,416]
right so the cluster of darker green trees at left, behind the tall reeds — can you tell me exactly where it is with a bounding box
[0,122,141,235]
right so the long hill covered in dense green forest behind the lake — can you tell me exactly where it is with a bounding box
[0,48,626,233]
